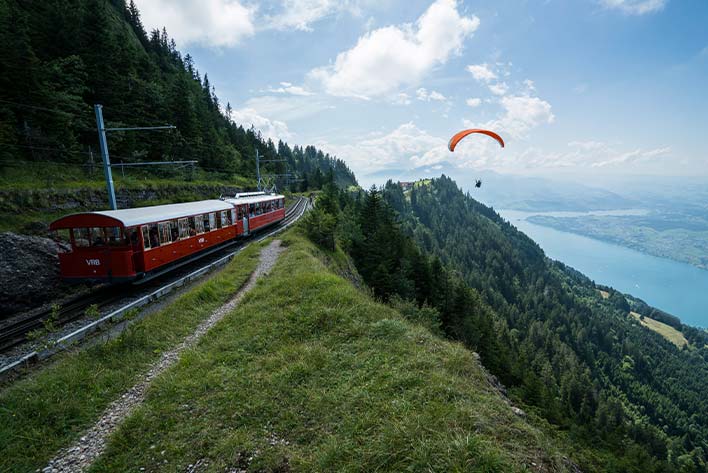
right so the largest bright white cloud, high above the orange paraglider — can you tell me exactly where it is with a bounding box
[310,0,479,99]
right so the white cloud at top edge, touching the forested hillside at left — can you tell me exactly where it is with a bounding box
[138,0,255,47]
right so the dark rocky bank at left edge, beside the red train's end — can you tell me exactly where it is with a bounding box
[0,232,72,319]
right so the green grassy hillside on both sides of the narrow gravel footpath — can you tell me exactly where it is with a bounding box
[0,230,573,472]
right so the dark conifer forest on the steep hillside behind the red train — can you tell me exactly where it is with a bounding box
[0,0,356,190]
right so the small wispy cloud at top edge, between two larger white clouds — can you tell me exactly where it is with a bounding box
[265,0,359,31]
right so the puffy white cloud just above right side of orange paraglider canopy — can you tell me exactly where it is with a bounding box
[472,95,555,138]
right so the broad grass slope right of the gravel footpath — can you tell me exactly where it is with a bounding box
[92,231,567,472]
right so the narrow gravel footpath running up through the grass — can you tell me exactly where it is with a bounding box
[42,240,285,473]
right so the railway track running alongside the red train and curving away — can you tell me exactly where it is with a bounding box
[0,197,308,358]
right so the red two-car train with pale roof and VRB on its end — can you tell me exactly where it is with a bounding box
[49,192,285,282]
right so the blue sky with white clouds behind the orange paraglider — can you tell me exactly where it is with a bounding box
[137,0,708,185]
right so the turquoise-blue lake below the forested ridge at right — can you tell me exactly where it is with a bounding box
[498,210,708,327]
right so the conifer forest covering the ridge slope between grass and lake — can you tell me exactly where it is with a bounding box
[307,176,708,472]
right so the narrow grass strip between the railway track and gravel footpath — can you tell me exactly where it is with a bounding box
[0,245,266,472]
